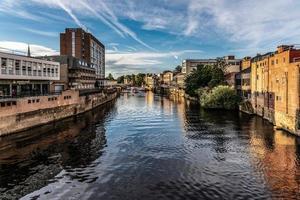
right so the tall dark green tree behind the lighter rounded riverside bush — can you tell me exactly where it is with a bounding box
[185,65,225,97]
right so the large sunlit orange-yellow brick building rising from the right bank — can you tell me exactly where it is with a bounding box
[251,45,300,134]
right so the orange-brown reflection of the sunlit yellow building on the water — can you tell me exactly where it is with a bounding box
[249,118,300,199]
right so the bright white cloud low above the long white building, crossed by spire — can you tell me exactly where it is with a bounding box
[0,41,59,56]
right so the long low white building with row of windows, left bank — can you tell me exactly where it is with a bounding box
[0,52,60,97]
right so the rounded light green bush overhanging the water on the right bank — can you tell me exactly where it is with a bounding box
[198,85,240,110]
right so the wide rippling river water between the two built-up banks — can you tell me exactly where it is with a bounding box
[0,93,300,200]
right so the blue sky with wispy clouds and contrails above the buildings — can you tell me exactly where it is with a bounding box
[0,0,300,76]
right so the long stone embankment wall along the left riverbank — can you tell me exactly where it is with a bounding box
[0,90,117,136]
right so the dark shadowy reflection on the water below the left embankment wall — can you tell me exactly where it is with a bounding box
[0,102,115,199]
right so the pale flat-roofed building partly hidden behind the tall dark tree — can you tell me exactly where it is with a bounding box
[181,59,217,75]
